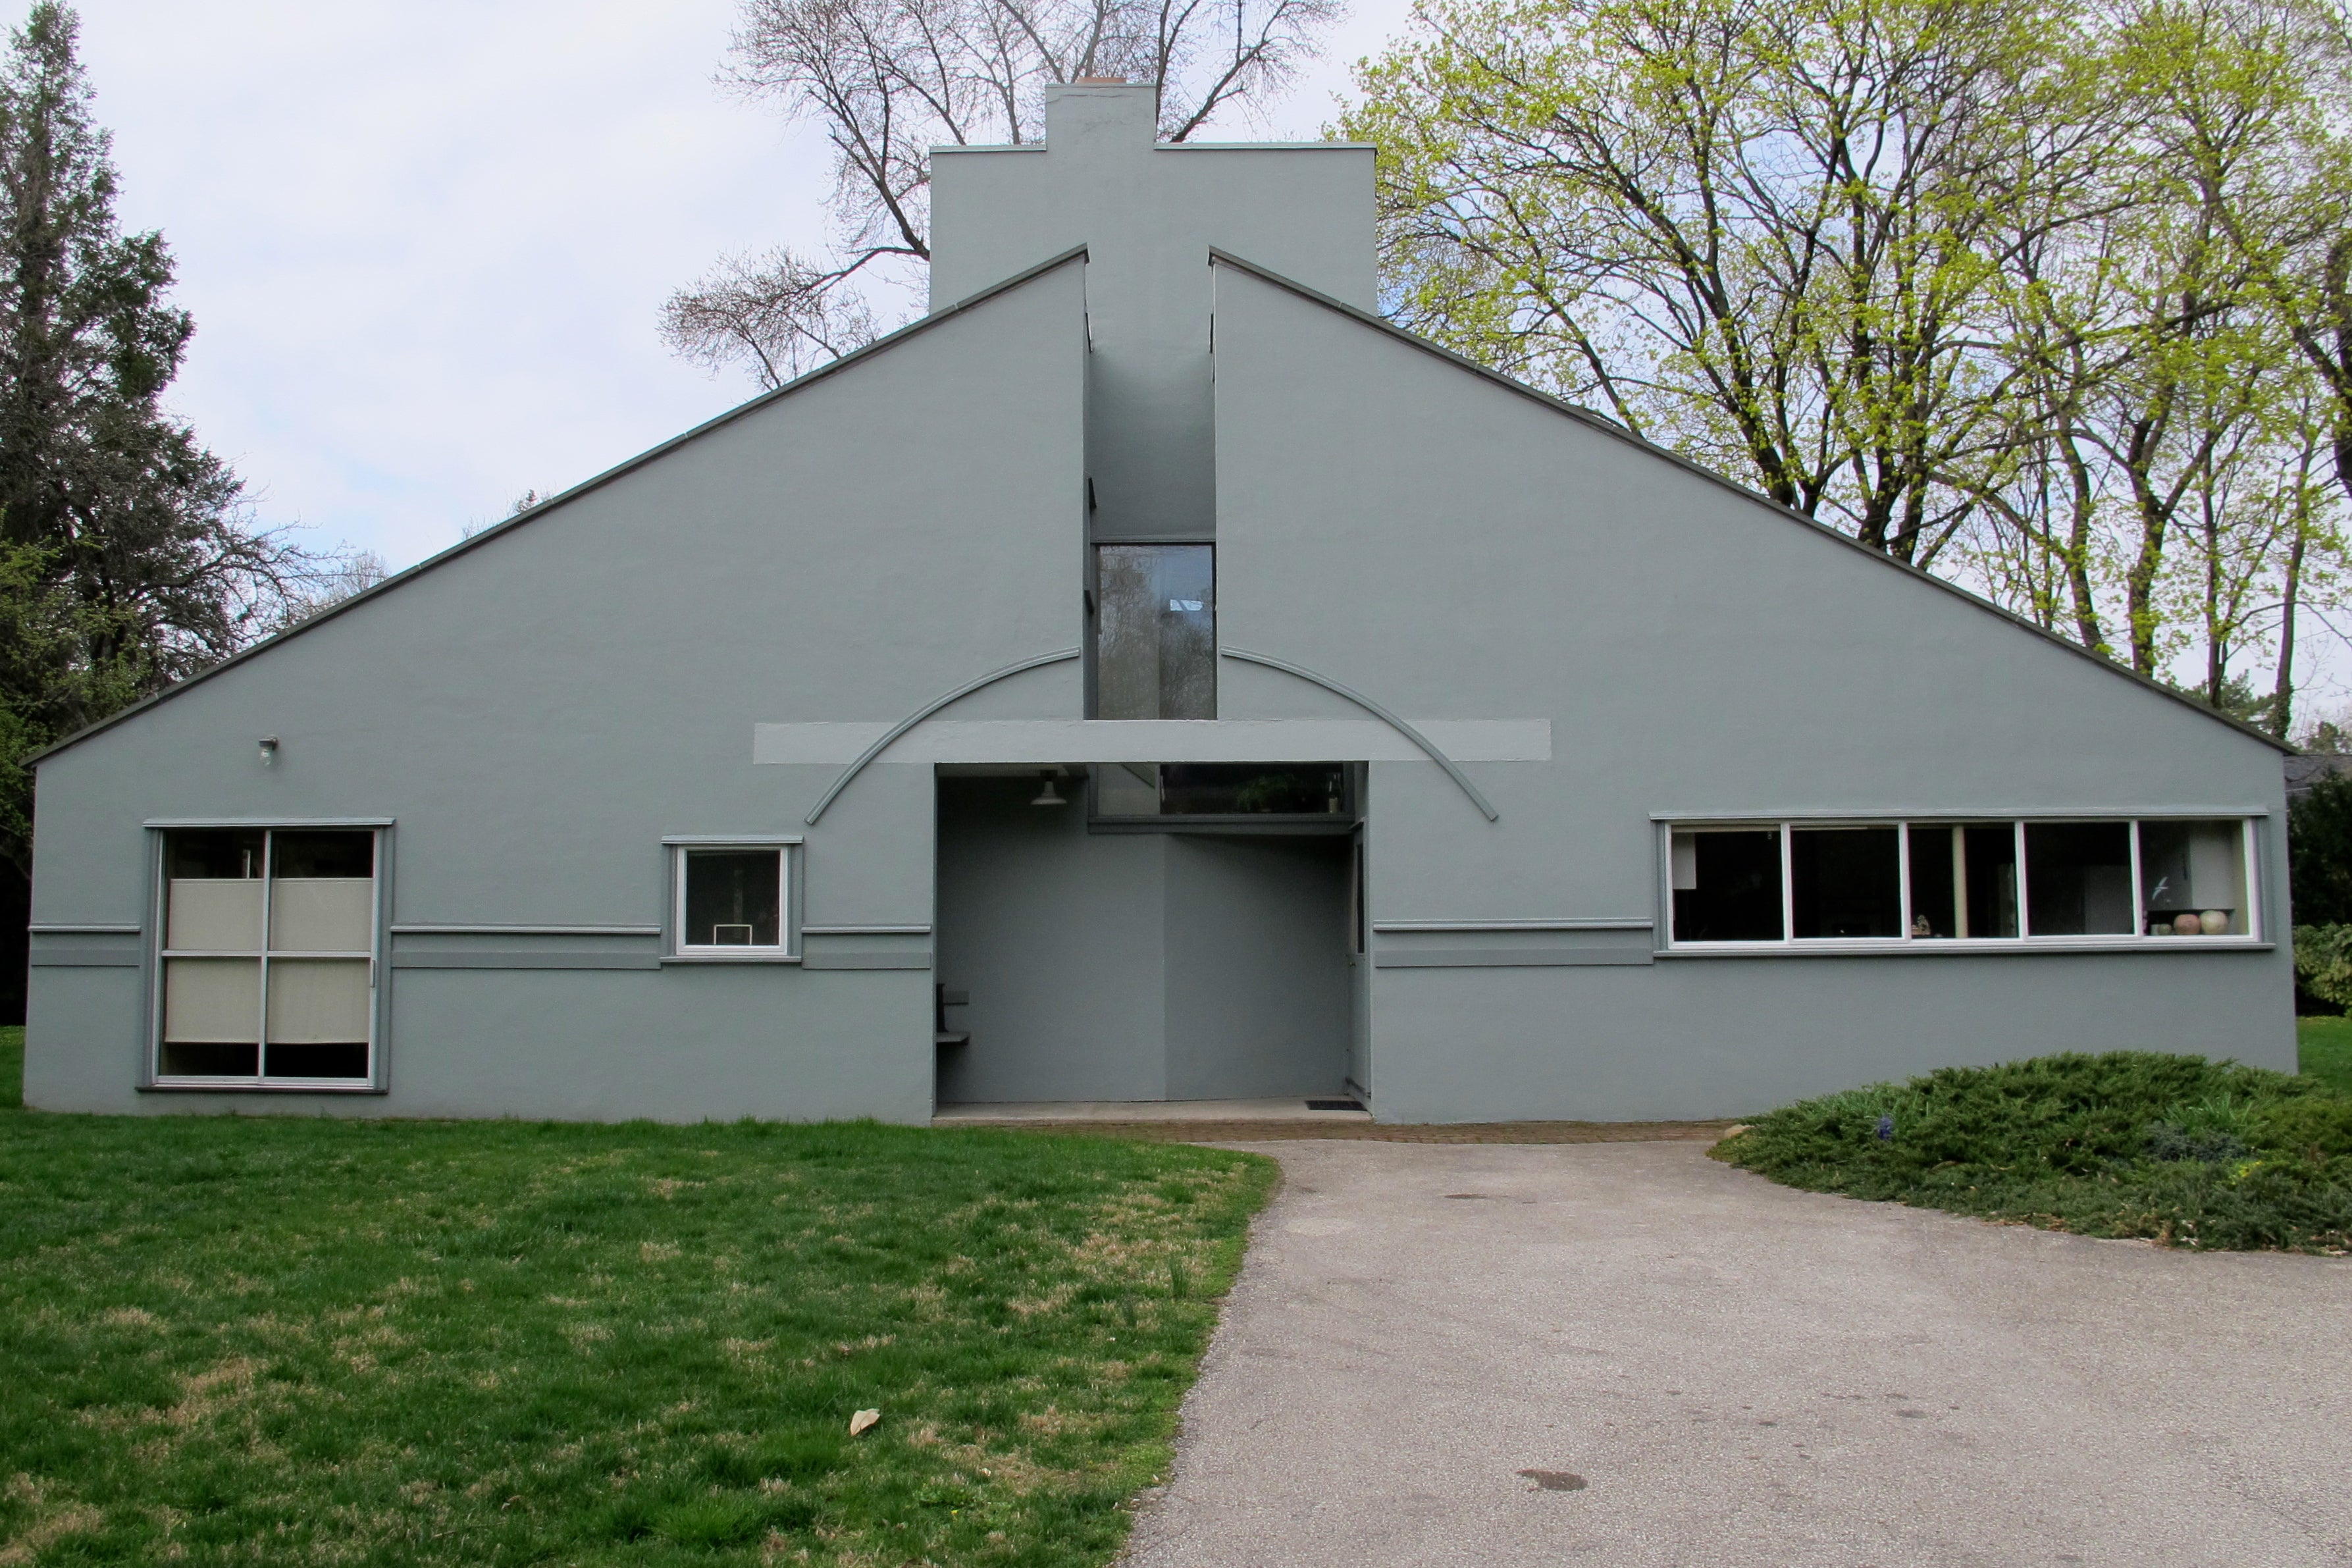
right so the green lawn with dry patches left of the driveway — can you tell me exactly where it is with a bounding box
[0,1112,1275,1568]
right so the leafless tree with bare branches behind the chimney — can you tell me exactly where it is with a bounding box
[661,0,1343,386]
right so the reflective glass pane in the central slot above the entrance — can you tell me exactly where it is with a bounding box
[1093,546,1216,719]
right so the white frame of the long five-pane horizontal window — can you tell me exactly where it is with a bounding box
[1651,808,2270,954]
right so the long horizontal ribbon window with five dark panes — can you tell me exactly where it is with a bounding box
[1665,818,2261,950]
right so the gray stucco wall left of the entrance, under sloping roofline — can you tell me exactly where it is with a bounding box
[26,263,1084,1121]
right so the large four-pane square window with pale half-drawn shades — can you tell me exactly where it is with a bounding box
[155,827,377,1084]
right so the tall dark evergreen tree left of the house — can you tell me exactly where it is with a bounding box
[0,0,355,907]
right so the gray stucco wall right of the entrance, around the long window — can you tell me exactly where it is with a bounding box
[1216,266,2293,1121]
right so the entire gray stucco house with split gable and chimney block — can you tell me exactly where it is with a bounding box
[26,85,2293,1121]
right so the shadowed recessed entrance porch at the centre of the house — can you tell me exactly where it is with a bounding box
[936,771,1355,1105]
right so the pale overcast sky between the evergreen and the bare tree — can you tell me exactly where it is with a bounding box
[82,0,1407,569]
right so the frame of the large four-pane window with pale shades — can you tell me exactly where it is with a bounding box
[141,818,393,1093]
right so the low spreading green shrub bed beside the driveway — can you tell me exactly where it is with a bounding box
[1715,1051,2352,1253]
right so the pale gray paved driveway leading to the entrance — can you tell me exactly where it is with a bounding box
[1129,1143,2352,1568]
